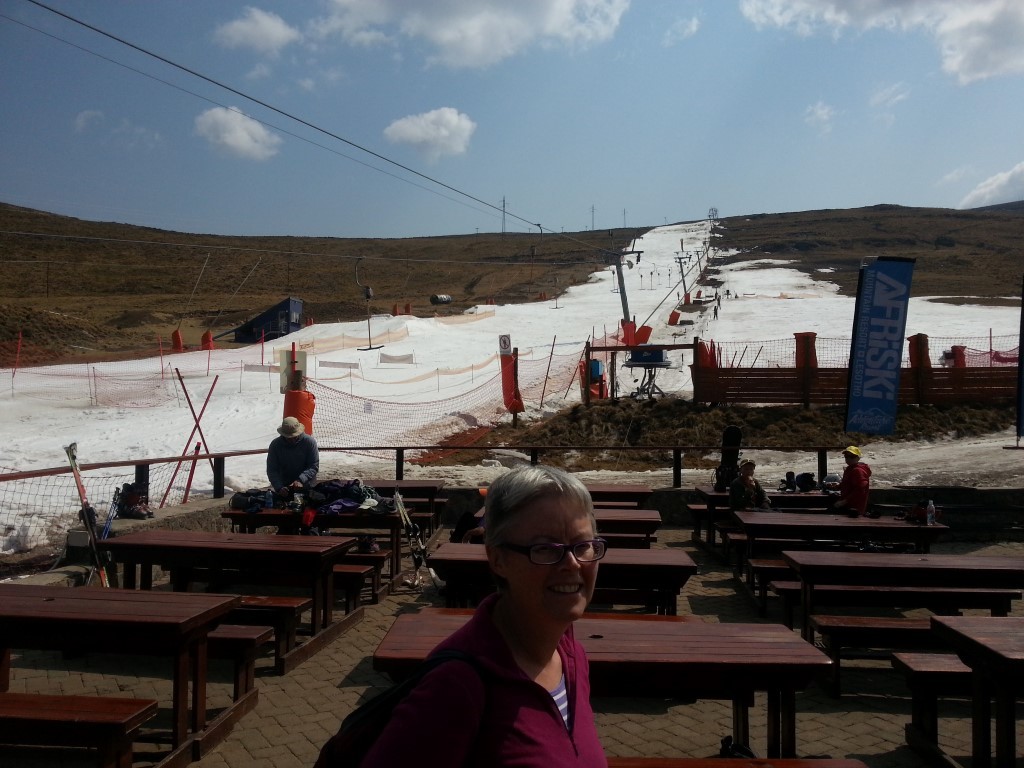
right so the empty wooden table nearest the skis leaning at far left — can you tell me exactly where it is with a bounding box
[97,528,362,643]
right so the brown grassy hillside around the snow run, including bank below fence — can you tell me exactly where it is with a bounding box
[0,204,1024,468]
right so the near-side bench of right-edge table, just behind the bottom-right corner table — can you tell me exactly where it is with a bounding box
[811,613,939,697]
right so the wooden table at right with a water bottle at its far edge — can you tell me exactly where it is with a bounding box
[732,510,949,554]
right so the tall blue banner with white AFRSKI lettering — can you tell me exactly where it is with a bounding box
[846,256,914,435]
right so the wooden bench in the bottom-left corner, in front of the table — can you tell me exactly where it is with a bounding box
[0,693,159,768]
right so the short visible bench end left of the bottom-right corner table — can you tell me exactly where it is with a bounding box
[892,652,973,758]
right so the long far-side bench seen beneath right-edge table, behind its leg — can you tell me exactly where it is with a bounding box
[770,581,1022,630]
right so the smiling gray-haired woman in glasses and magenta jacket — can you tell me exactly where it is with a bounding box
[361,466,607,768]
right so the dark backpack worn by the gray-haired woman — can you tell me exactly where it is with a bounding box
[313,649,482,768]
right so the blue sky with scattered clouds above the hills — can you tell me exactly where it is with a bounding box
[0,0,1024,238]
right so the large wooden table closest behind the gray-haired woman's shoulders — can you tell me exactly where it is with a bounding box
[374,610,831,758]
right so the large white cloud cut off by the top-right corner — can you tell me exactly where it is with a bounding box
[739,0,1024,84]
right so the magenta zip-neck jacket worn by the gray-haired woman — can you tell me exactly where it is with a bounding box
[361,594,607,768]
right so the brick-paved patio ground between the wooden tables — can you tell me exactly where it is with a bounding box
[0,526,1024,768]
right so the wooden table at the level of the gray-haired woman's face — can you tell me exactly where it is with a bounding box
[428,543,697,615]
